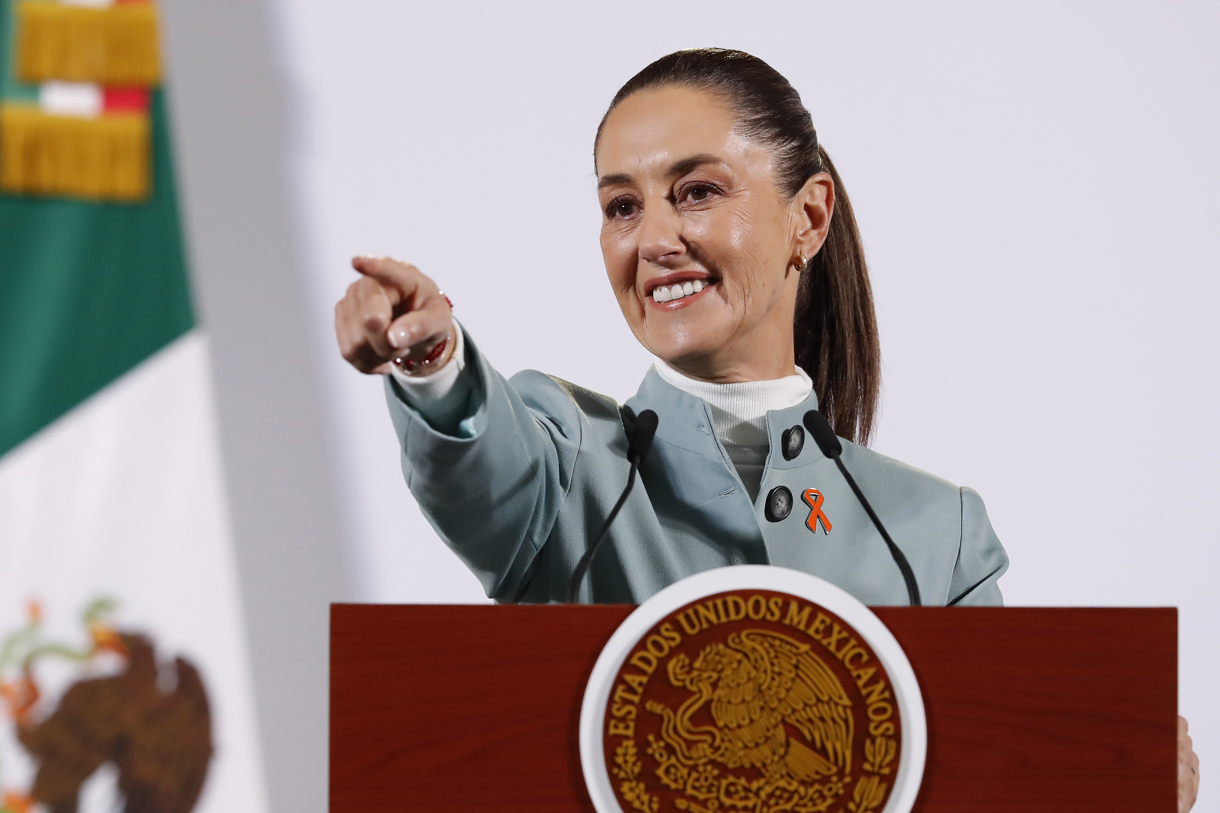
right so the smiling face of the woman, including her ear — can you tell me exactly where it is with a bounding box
[597,87,833,381]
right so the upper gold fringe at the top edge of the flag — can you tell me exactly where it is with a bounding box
[16,0,161,87]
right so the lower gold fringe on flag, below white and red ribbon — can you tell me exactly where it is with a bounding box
[0,104,151,203]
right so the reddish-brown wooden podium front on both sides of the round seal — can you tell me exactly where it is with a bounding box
[331,604,1177,813]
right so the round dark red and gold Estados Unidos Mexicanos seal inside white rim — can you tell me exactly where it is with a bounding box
[603,591,902,813]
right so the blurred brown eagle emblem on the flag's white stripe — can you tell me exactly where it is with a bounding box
[0,598,214,813]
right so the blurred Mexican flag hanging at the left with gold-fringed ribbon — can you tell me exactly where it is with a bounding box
[0,0,266,813]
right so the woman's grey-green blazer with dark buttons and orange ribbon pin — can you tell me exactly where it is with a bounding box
[386,333,1008,605]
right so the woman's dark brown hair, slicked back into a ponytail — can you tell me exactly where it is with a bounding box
[593,48,881,443]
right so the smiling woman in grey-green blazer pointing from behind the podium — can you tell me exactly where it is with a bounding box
[336,49,1198,809]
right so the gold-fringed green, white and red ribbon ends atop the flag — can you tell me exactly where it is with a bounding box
[0,0,161,201]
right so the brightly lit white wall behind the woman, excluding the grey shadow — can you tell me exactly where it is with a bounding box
[264,0,1220,795]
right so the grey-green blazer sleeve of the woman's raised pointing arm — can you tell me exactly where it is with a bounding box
[386,333,582,601]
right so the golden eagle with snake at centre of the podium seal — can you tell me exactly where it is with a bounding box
[648,622,853,782]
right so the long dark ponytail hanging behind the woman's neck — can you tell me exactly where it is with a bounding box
[793,146,881,446]
